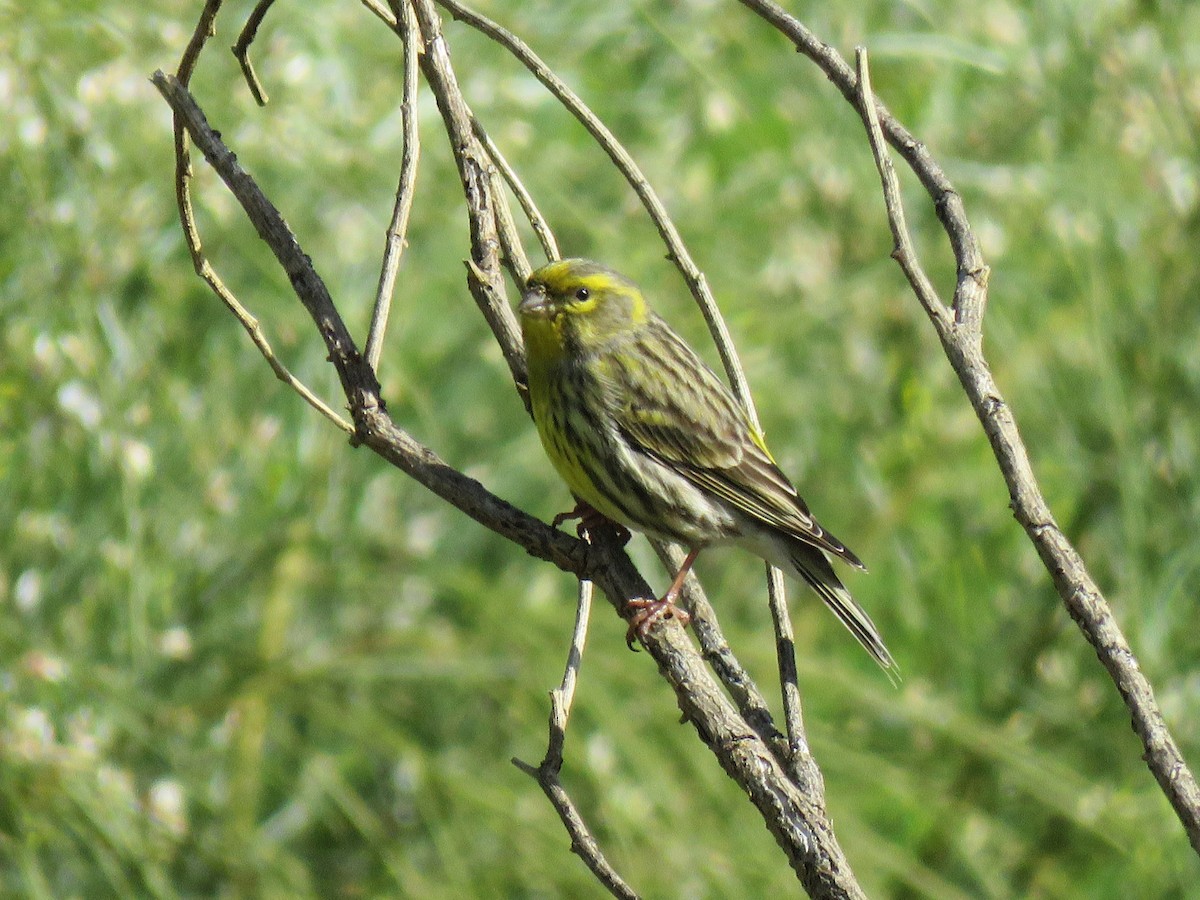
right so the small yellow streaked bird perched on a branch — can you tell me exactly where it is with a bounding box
[517,258,896,676]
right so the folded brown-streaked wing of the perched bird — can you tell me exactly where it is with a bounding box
[610,319,864,569]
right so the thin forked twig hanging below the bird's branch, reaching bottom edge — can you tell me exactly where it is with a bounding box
[512,580,637,900]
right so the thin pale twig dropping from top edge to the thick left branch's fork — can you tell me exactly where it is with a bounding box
[366,4,421,372]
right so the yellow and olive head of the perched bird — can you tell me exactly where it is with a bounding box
[517,259,650,360]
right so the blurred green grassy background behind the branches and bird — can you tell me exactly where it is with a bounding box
[0,0,1200,898]
